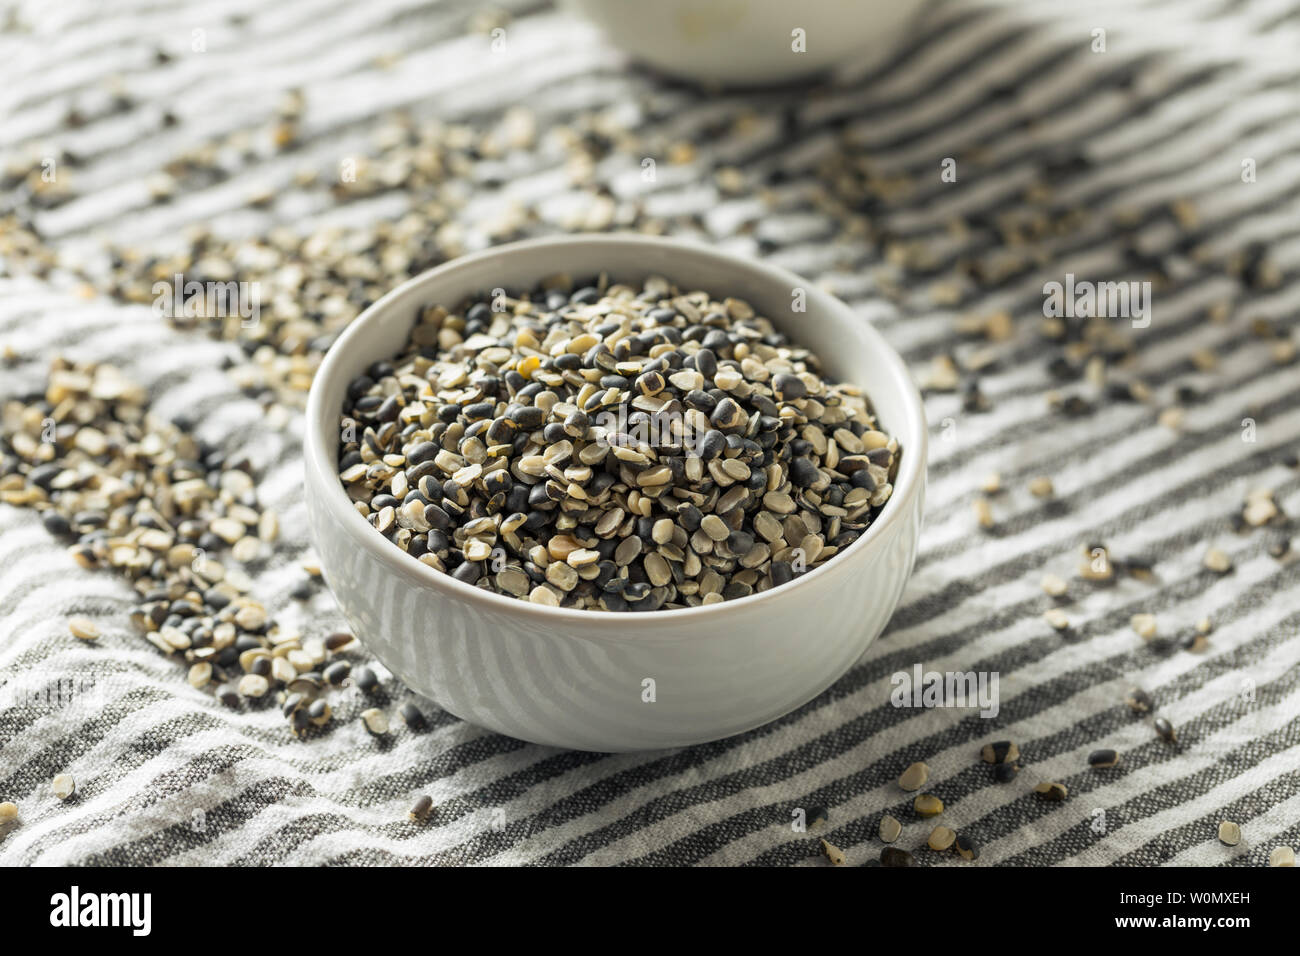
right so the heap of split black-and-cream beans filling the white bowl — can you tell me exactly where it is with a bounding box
[338,276,898,611]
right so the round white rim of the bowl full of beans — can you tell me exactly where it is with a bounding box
[303,233,928,626]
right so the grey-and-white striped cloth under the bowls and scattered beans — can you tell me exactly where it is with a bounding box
[0,0,1300,865]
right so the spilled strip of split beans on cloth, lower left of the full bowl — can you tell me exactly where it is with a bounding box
[0,359,350,732]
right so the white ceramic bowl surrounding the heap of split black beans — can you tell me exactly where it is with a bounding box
[306,235,926,750]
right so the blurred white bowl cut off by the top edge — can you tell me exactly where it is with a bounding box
[568,0,922,86]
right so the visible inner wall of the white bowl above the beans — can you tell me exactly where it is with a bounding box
[306,234,926,619]
